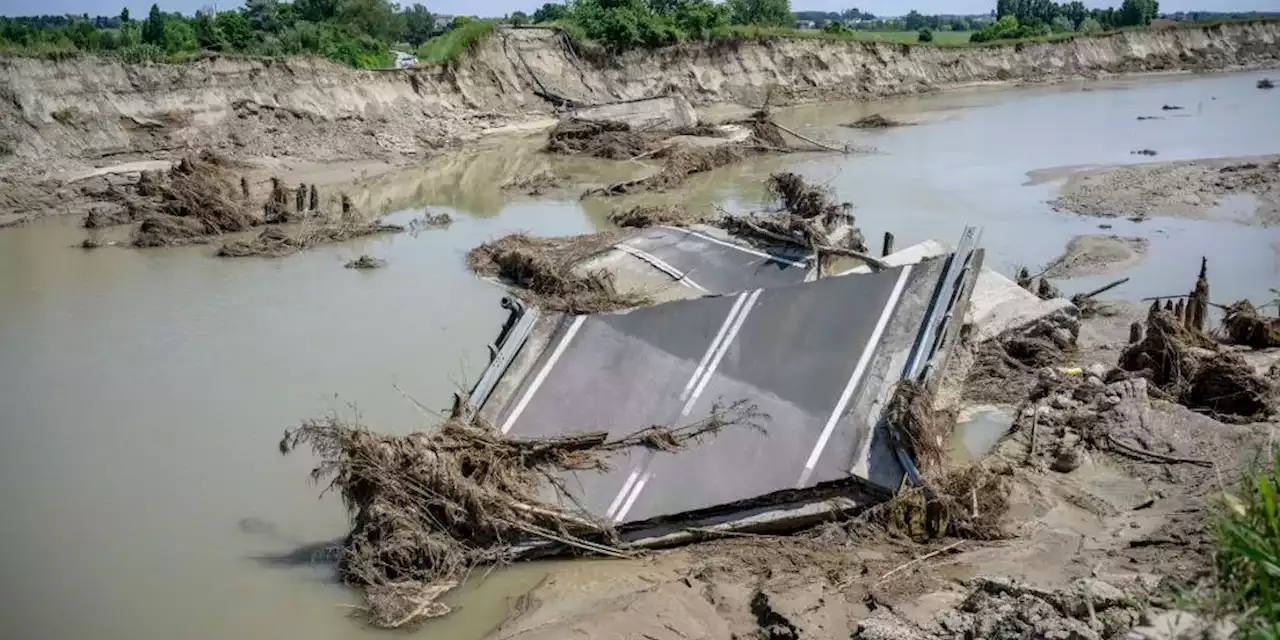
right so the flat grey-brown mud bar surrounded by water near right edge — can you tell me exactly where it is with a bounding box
[1050,155,1280,225]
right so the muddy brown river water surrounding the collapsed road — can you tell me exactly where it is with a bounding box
[0,74,1280,640]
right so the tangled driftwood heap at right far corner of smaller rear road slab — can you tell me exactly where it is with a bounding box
[721,172,867,257]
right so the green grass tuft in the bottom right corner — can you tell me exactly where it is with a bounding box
[1217,448,1280,639]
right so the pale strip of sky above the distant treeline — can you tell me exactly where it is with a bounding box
[0,0,1280,17]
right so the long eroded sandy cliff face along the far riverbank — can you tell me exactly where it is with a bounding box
[0,23,1280,174]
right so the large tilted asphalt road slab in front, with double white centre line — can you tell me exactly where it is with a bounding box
[471,227,972,531]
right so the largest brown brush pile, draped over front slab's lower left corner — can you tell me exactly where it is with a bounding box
[280,402,767,627]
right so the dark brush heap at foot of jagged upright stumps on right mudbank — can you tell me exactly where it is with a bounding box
[1120,310,1275,419]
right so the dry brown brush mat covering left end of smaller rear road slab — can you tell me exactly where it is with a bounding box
[467,233,652,314]
